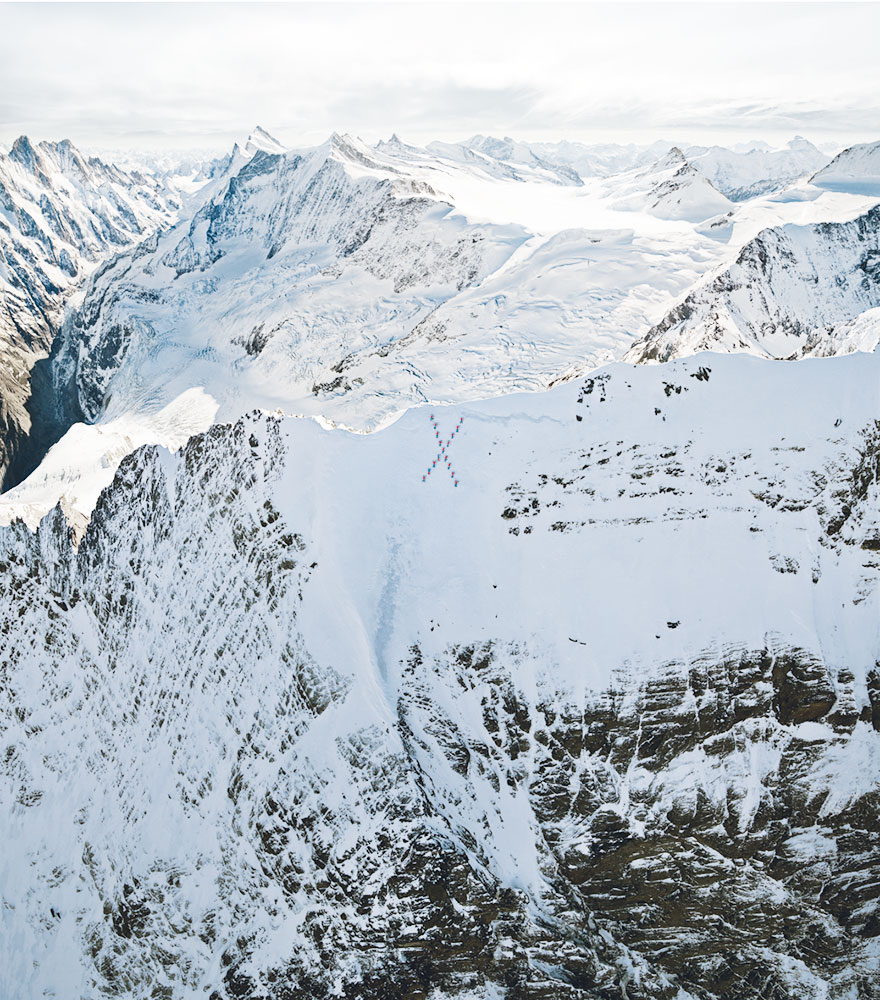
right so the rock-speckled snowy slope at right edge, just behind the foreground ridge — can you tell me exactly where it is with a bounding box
[627,206,880,361]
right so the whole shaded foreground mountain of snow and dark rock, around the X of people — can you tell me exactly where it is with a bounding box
[0,355,880,1000]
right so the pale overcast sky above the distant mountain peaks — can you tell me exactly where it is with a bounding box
[0,2,880,149]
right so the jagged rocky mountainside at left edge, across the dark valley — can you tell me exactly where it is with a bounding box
[0,136,180,488]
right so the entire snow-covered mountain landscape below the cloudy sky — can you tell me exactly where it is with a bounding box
[0,128,880,1000]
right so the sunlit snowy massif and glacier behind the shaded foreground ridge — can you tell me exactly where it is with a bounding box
[0,129,874,523]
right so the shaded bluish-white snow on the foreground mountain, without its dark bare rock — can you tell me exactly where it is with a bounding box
[0,355,880,997]
